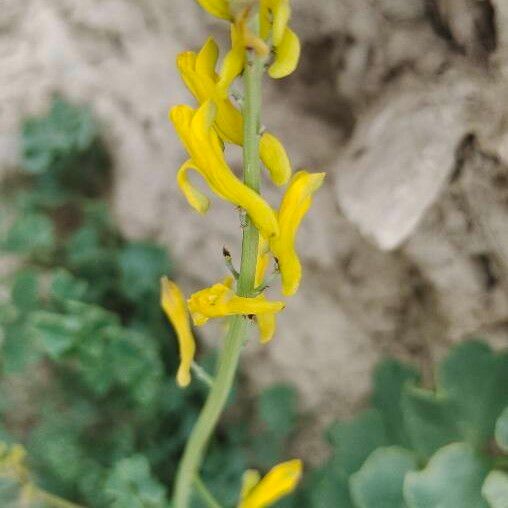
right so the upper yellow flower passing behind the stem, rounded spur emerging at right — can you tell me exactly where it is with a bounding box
[177,38,291,185]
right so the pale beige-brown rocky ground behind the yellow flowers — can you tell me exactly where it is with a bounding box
[0,0,508,457]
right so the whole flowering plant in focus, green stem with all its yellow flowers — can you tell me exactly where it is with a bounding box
[161,0,324,508]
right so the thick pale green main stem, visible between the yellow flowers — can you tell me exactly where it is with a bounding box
[174,26,264,508]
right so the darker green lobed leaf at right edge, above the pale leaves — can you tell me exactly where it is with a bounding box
[437,341,508,448]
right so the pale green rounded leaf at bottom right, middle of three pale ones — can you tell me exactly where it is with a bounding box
[404,443,489,508]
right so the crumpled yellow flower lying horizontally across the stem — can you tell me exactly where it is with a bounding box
[187,277,284,326]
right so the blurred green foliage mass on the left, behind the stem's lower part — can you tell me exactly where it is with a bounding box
[0,98,296,508]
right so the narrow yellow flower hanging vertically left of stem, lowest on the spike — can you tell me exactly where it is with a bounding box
[161,277,196,387]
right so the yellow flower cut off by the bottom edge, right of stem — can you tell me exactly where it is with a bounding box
[238,459,302,508]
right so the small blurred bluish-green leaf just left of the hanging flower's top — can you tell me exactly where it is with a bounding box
[118,242,170,302]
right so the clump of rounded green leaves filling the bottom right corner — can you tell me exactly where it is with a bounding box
[285,341,508,508]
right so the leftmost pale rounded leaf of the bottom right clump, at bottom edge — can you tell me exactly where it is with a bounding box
[349,447,417,508]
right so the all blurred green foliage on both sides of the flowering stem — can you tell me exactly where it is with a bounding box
[0,94,508,508]
